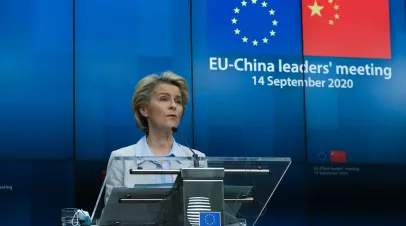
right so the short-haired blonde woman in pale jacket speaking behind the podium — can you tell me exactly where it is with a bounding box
[105,72,205,204]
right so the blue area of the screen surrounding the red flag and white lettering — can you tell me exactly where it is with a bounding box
[192,0,406,163]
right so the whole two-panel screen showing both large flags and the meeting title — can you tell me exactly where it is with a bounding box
[192,0,406,163]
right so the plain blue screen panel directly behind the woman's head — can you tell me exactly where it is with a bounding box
[75,0,193,160]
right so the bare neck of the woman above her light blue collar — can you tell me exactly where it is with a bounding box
[147,128,173,156]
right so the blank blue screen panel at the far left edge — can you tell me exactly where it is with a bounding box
[0,0,74,159]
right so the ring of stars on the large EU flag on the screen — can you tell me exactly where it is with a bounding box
[231,0,279,46]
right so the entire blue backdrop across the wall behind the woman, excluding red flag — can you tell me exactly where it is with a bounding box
[0,0,406,225]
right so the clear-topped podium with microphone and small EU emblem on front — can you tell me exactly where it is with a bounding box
[92,156,291,226]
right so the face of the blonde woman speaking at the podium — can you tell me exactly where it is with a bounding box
[140,84,183,130]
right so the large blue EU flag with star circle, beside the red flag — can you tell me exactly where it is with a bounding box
[206,0,302,56]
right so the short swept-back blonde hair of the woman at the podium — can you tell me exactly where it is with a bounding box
[132,71,189,133]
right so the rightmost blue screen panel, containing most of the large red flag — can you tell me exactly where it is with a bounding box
[303,0,406,164]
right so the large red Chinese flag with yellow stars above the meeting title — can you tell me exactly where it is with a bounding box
[302,0,391,59]
